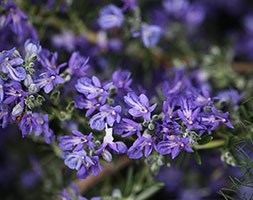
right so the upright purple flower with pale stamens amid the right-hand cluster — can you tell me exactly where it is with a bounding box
[178,99,200,129]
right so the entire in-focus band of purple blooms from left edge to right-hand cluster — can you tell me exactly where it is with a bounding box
[0,40,233,178]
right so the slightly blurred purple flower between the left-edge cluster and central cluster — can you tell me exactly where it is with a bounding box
[68,52,89,76]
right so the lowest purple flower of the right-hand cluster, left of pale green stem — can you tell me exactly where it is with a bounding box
[156,135,193,159]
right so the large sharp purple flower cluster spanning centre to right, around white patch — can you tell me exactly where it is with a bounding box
[56,68,233,180]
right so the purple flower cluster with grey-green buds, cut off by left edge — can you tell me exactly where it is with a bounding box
[0,40,65,143]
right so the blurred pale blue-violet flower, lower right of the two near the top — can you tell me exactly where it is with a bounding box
[141,25,162,47]
